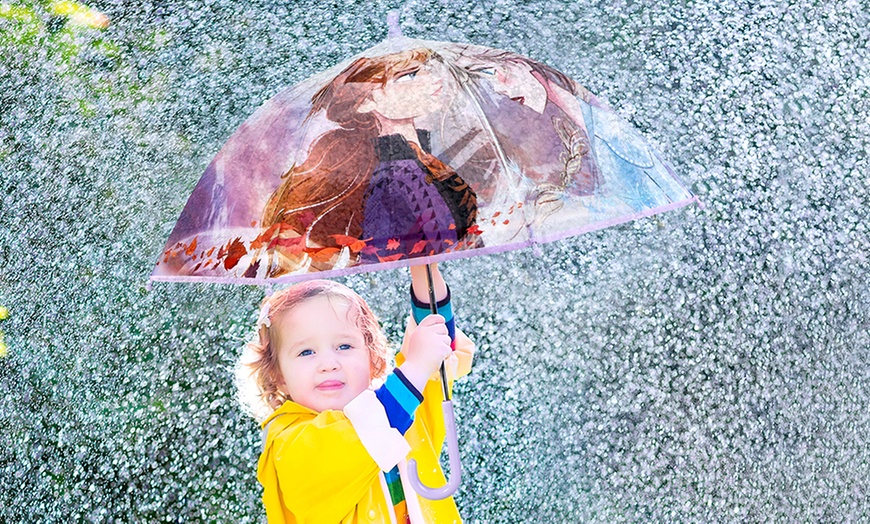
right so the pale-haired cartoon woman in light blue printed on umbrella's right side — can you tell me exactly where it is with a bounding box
[456,46,686,216]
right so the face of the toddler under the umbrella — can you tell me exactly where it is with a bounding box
[276,296,371,411]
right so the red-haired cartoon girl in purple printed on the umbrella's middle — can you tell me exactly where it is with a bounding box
[260,49,477,276]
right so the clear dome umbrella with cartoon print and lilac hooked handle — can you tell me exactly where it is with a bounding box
[151,17,697,498]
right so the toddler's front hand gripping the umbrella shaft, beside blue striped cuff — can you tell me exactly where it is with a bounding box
[399,315,452,391]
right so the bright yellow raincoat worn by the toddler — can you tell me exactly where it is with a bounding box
[257,319,474,524]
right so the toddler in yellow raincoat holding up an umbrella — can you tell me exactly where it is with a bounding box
[238,265,474,524]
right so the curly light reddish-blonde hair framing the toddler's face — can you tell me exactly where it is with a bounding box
[236,280,387,421]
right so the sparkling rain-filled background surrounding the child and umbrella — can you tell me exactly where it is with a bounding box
[0,0,870,523]
